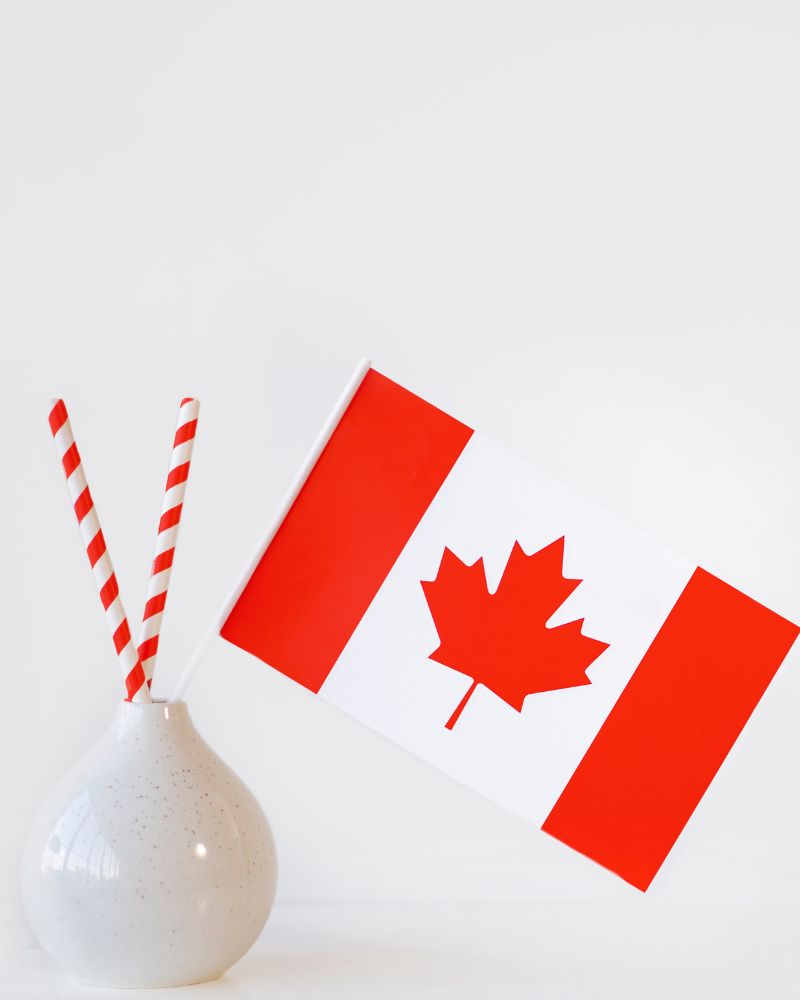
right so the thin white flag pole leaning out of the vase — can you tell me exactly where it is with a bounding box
[169,358,371,701]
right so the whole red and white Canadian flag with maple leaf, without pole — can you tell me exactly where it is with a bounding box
[221,369,800,889]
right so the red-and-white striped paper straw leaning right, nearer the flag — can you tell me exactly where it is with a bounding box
[139,397,200,685]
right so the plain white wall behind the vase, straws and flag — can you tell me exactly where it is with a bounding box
[0,0,800,952]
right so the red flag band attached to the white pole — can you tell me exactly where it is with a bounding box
[221,369,472,691]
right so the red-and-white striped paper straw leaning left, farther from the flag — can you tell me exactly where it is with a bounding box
[50,399,151,702]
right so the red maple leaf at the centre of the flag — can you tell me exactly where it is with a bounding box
[422,538,608,729]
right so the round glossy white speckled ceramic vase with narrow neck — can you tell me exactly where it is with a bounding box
[22,702,277,988]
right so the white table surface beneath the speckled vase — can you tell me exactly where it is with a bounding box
[0,904,800,1000]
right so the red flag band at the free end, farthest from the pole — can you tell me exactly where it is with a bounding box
[543,569,800,890]
